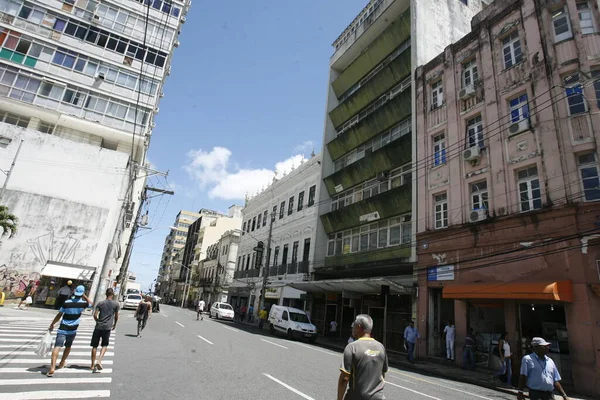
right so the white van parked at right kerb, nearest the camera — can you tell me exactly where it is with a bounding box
[269,306,317,342]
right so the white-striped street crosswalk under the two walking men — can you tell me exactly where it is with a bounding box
[0,316,115,400]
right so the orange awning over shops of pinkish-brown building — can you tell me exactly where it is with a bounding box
[442,281,573,303]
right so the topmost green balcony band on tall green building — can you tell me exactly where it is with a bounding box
[331,9,410,98]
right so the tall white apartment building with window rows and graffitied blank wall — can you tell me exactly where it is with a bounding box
[0,0,190,300]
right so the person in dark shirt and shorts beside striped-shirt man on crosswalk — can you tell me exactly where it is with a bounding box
[90,288,119,372]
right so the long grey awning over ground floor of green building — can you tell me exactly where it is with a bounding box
[289,275,414,294]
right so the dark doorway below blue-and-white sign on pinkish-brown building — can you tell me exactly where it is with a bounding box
[427,288,454,357]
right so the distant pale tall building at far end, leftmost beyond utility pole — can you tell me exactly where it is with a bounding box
[156,210,200,296]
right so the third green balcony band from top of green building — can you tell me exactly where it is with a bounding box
[327,88,412,160]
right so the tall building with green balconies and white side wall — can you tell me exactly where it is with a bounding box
[302,0,482,350]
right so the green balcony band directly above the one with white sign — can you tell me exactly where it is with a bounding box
[323,134,412,196]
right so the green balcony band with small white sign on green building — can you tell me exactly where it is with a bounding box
[321,184,412,234]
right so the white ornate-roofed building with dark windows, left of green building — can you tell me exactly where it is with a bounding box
[229,155,321,313]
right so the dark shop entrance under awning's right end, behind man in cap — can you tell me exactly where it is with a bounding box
[519,304,573,385]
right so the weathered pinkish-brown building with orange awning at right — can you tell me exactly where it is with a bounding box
[416,0,600,397]
